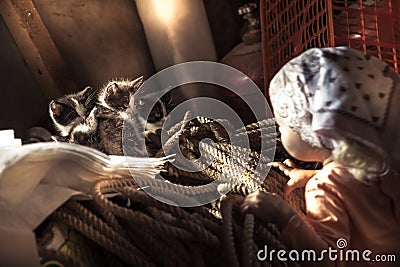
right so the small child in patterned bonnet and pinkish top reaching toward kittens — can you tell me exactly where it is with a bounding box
[242,47,400,266]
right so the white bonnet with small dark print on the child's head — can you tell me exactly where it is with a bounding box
[269,47,400,163]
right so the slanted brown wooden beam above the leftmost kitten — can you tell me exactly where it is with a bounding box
[0,0,77,99]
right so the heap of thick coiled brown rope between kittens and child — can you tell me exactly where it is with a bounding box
[36,118,304,266]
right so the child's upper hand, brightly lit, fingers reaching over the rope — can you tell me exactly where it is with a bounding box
[270,159,319,195]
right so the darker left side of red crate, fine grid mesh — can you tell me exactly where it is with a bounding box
[260,0,333,90]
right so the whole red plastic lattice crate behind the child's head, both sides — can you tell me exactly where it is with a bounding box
[260,0,400,96]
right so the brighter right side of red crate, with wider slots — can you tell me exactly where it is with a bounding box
[332,0,400,71]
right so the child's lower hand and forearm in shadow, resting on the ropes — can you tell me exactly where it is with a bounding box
[241,191,295,229]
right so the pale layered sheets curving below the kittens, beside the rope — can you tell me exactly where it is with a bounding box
[0,141,169,266]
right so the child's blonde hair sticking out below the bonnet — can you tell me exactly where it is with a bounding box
[332,139,389,184]
